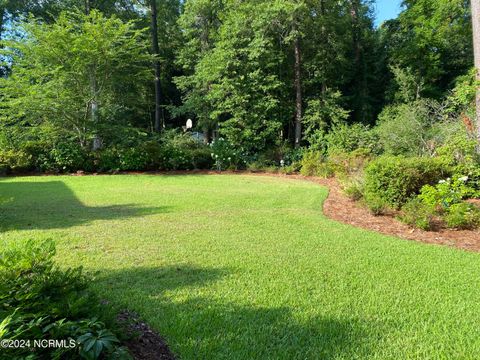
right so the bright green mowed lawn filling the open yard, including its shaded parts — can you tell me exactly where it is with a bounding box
[0,175,480,360]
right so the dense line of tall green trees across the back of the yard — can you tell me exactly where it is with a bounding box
[0,0,473,171]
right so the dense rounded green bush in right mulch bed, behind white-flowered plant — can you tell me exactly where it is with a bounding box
[365,156,451,209]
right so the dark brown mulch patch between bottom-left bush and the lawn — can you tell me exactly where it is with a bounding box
[117,310,176,360]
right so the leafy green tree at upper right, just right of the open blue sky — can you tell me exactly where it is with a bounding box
[381,0,473,99]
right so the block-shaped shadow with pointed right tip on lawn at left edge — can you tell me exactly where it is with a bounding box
[0,181,168,231]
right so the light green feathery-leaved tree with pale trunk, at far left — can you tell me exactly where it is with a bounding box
[0,10,151,147]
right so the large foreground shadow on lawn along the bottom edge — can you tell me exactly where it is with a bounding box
[98,266,375,360]
